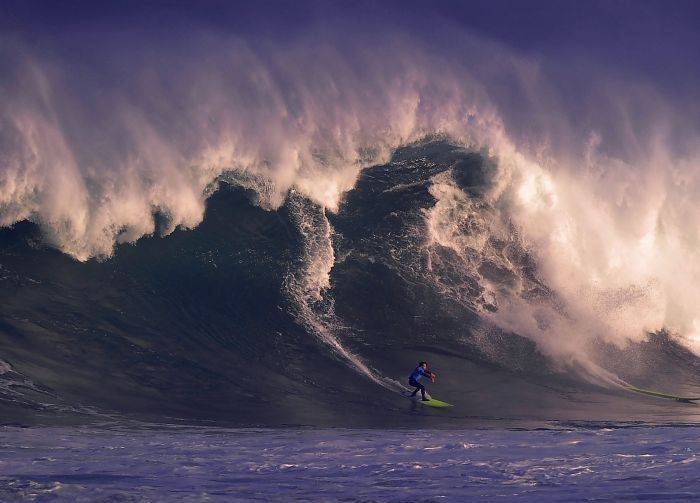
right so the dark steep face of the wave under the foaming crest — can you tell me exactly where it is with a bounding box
[0,140,698,425]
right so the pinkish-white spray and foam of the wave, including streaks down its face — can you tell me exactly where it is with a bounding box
[0,5,700,414]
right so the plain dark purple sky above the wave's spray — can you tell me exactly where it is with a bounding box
[5,0,700,89]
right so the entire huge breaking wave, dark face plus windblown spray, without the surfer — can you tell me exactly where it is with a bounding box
[0,16,700,424]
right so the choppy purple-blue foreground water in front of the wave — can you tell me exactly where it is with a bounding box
[0,424,700,502]
